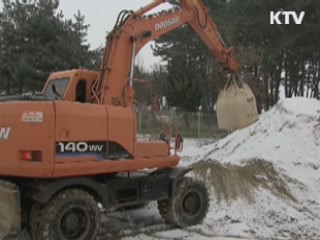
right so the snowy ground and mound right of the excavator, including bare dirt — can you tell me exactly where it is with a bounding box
[100,98,320,240]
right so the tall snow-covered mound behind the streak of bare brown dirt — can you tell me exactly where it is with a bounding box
[195,98,320,167]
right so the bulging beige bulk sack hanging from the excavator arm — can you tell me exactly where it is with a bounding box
[217,76,259,131]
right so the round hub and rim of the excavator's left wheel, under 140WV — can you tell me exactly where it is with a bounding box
[60,207,90,240]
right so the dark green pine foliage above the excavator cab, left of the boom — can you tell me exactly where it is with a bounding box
[0,0,101,94]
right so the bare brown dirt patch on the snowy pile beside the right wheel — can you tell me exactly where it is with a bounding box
[193,159,296,204]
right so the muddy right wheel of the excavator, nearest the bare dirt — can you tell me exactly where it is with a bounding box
[158,178,209,228]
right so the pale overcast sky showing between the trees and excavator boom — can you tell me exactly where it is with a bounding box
[59,0,170,69]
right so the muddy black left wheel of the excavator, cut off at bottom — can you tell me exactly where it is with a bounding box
[30,189,101,240]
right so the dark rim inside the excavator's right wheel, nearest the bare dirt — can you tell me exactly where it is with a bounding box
[182,192,201,217]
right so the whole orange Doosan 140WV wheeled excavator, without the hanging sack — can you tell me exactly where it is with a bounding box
[0,0,245,240]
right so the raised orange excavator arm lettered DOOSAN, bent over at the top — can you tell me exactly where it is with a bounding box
[92,0,239,106]
